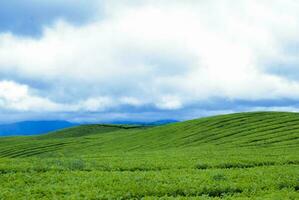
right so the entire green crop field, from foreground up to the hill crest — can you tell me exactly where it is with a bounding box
[0,112,299,200]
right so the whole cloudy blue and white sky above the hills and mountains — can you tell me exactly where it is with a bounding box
[0,0,299,123]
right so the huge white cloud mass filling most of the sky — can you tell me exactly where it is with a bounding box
[0,0,299,117]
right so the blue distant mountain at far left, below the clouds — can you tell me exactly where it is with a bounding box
[0,121,79,136]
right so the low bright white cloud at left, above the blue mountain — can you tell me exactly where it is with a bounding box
[0,81,130,112]
